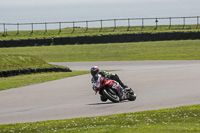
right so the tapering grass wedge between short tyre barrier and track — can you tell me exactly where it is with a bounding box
[0,70,89,91]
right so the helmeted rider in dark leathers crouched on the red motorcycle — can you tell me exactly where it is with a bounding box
[90,66,128,101]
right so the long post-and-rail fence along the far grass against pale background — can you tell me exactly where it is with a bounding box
[0,16,200,36]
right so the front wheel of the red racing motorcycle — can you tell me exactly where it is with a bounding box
[102,88,120,103]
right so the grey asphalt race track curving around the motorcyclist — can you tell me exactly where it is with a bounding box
[0,60,200,124]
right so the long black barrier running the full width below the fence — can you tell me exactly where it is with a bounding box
[0,32,200,47]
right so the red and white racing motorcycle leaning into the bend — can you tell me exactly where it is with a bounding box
[93,74,136,103]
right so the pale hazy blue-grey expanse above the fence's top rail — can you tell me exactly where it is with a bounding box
[0,0,200,23]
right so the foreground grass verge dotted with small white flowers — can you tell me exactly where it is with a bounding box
[0,105,200,133]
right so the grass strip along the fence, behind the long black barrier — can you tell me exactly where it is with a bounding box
[0,25,200,40]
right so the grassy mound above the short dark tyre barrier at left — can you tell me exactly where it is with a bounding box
[0,54,65,71]
